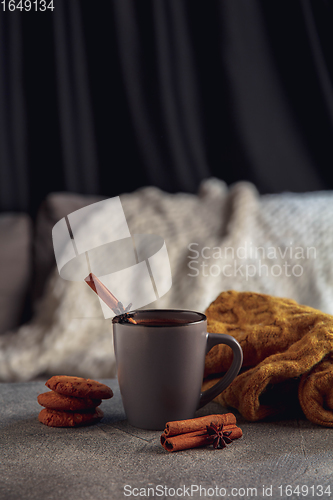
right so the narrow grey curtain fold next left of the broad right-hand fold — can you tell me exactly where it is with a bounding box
[153,0,209,191]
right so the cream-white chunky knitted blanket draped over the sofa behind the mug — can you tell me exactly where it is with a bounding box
[0,179,333,381]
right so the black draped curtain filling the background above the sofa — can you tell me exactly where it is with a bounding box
[0,0,333,216]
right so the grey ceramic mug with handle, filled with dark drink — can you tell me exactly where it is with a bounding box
[113,309,243,430]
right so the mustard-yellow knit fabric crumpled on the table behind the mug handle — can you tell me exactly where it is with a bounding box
[203,291,333,427]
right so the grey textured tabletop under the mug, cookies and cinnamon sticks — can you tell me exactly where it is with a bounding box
[0,380,333,500]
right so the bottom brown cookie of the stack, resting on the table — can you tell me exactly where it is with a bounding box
[38,408,104,427]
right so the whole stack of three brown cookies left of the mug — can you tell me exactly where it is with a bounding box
[37,375,113,427]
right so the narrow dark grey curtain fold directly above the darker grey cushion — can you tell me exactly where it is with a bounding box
[54,0,99,194]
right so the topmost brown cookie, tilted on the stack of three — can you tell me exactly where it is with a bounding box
[45,375,113,399]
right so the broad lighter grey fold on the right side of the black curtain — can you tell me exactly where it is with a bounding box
[220,1,324,191]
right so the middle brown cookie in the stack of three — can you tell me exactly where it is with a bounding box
[37,391,102,411]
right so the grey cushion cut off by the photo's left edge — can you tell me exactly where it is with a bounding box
[0,213,32,334]
